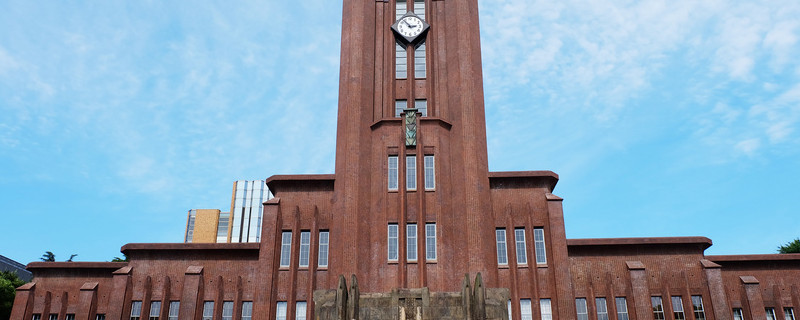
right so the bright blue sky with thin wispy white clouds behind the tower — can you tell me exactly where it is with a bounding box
[0,0,800,263]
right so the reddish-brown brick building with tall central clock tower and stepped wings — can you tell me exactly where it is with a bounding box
[12,0,800,320]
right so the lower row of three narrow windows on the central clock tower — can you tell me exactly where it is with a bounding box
[387,223,436,262]
